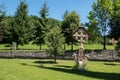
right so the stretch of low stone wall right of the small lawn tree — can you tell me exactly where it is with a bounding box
[64,50,120,61]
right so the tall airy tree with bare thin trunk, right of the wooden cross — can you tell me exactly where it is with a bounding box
[92,0,112,49]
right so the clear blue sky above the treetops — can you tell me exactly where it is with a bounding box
[0,0,96,23]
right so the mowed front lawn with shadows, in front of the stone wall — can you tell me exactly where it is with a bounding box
[0,59,120,80]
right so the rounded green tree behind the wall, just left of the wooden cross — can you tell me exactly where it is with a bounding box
[61,11,80,50]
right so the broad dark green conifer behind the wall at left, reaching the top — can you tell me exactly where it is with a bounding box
[12,1,32,49]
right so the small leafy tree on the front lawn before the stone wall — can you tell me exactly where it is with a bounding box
[45,27,65,63]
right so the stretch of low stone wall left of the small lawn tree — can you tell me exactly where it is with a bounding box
[0,51,48,59]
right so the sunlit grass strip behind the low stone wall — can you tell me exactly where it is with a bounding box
[0,44,115,51]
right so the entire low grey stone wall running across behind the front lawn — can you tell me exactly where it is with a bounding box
[0,50,120,61]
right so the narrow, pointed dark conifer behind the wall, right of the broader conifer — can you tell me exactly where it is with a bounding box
[33,3,48,50]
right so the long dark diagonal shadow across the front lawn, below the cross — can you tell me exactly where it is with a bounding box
[21,61,120,80]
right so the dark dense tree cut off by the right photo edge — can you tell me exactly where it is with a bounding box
[109,0,120,40]
